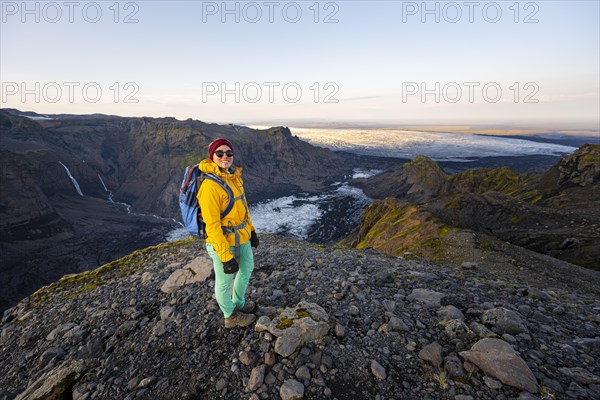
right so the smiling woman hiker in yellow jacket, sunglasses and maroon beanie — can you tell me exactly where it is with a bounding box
[198,138,258,329]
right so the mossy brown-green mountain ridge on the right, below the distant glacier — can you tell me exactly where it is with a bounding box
[352,144,600,269]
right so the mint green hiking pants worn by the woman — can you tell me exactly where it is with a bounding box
[206,241,254,318]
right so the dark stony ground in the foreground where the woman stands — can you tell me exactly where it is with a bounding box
[0,234,600,400]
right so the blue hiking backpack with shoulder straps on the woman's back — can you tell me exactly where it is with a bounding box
[179,164,234,239]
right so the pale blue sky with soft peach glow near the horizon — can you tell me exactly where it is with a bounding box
[0,0,600,130]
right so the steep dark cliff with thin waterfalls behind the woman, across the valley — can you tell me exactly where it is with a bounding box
[0,110,357,216]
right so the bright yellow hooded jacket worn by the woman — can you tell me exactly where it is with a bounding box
[198,159,254,262]
